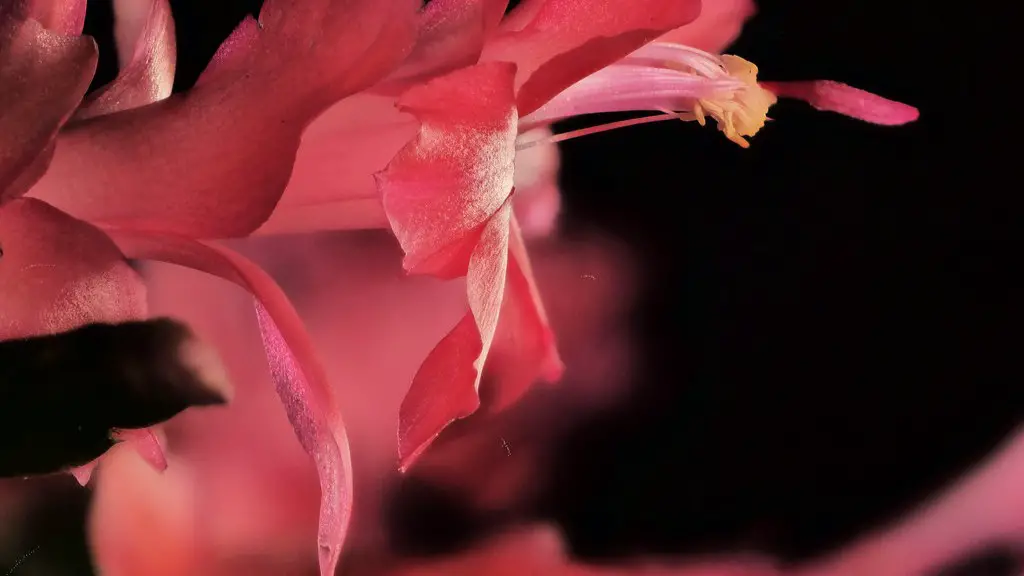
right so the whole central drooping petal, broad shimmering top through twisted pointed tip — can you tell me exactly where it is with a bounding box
[378,63,517,468]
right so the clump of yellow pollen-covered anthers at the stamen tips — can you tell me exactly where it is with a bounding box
[693,54,776,148]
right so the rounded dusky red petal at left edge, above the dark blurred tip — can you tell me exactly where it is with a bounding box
[0,199,146,339]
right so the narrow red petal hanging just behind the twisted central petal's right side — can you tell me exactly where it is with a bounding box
[486,213,565,410]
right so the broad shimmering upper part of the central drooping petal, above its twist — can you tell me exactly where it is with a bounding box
[378,63,518,277]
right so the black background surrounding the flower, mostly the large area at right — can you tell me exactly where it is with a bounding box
[9,0,1024,574]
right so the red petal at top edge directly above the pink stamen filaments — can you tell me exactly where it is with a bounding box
[482,0,700,116]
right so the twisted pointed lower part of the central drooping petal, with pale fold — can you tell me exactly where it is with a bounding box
[398,203,512,471]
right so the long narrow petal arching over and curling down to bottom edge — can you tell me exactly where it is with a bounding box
[105,231,352,576]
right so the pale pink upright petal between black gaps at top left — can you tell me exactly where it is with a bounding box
[75,0,176,120]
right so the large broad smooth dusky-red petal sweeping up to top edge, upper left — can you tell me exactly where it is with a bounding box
[31,0,415,238]
